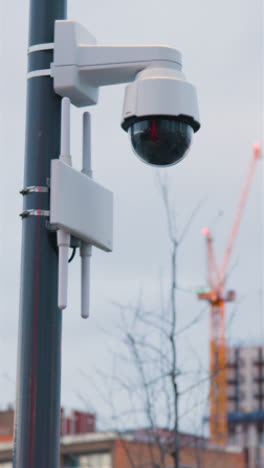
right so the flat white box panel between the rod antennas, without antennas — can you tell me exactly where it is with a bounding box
[50,159,113,252]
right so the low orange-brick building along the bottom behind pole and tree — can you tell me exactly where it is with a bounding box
[0,432,245,468]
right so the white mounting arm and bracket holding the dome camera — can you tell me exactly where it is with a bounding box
[51,21,183,107]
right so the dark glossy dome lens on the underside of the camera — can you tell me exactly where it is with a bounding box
[129,117,193,166]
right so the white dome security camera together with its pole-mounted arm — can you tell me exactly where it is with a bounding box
[52,21,200,166]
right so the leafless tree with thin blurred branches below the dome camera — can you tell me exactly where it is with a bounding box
[76,179,243,468]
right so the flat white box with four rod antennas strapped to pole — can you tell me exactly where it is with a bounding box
[50,98,113,318]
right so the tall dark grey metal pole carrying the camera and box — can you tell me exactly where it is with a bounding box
[13,0,66,468]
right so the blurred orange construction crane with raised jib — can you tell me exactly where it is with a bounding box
[198,143,261,444]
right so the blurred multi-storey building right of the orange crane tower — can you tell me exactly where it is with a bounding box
[227,346,264,468]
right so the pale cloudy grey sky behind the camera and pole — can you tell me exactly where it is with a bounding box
[0,0,263,432]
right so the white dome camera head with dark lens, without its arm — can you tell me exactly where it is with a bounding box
[121,68,200,167]
